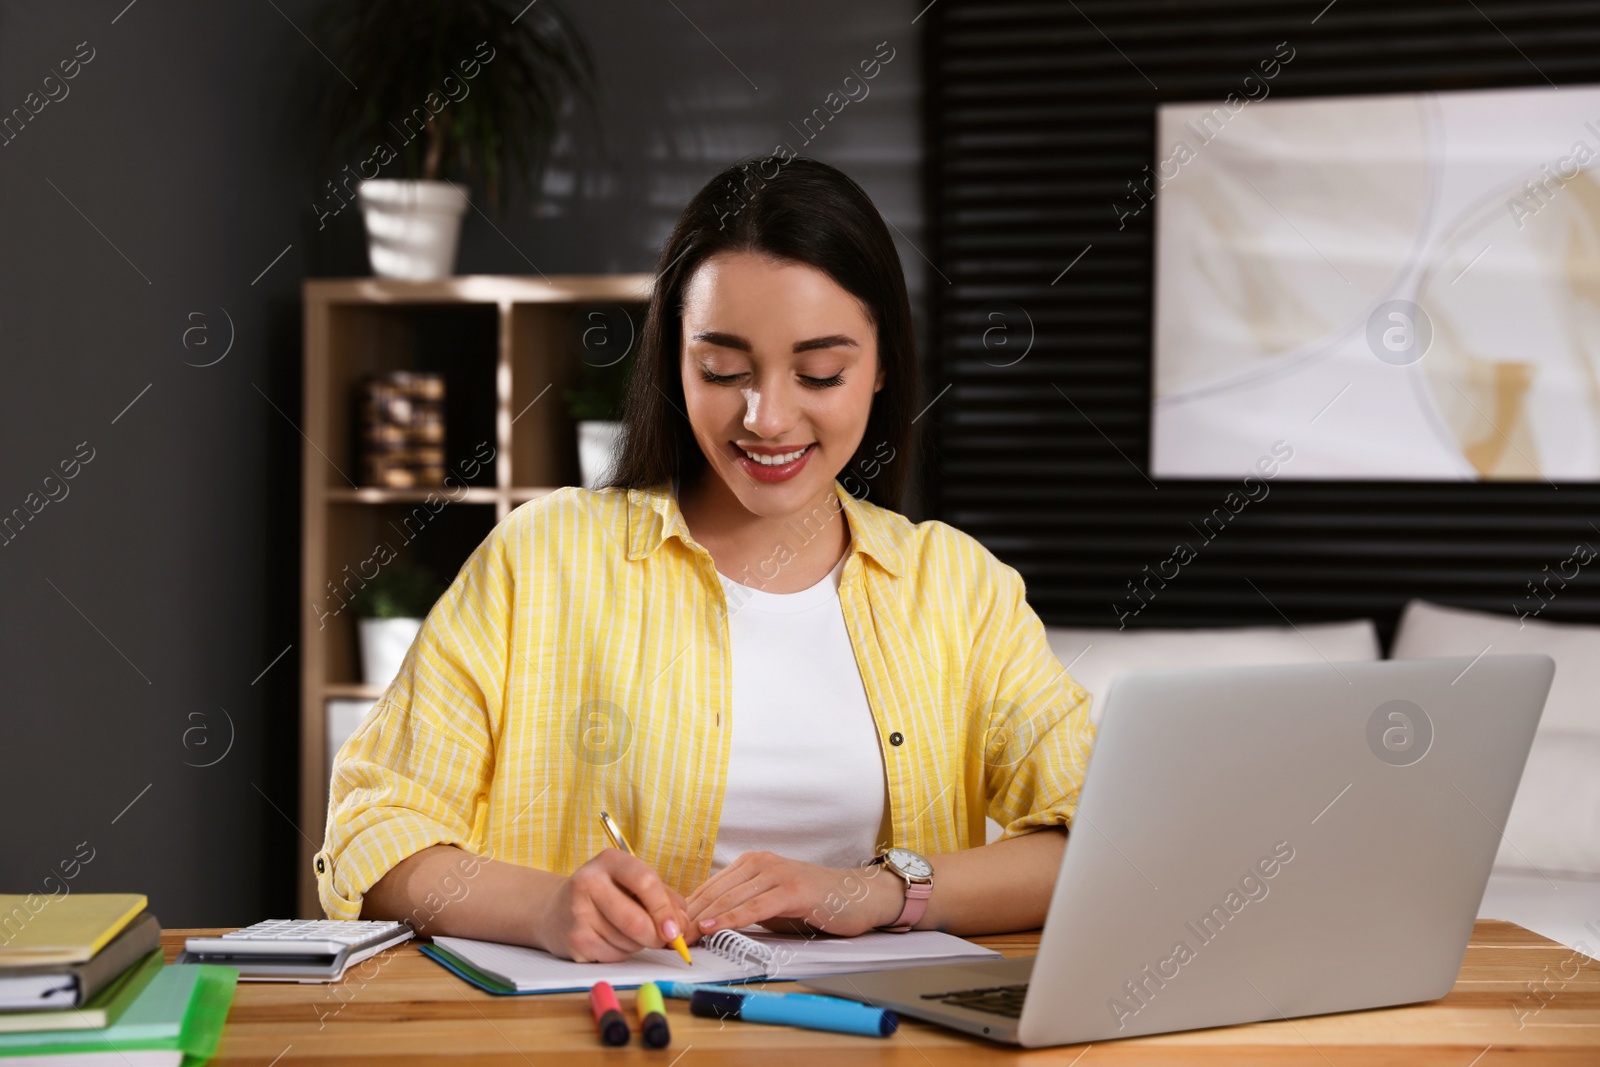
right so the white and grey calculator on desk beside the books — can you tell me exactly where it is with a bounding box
[178,918,411,982]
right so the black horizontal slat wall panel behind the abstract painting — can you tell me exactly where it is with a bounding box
[922,0,1600,643]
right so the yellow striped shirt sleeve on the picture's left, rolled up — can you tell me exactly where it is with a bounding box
[314,528,514,918]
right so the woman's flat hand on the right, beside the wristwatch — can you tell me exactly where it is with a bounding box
[686,853,906,937]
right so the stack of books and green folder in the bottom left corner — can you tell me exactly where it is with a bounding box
[0,893,238,1067]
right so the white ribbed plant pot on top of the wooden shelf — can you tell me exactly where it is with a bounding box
[357,178,469,282]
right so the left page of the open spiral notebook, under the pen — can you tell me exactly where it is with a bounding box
[434,937,762,993]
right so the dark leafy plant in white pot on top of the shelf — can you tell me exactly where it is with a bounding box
[310,0,594,280]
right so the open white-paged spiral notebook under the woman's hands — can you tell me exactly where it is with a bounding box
[422,926,1000,993]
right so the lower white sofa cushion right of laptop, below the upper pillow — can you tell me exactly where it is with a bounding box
[1494,726,1600,878]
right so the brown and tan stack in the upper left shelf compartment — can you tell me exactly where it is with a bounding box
[360,371,445,490]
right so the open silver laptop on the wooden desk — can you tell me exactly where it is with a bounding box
[803,656,1555,1046]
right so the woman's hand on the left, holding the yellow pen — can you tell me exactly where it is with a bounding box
[536,848,690,963]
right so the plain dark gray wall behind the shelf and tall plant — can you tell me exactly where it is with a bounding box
[0,0,926,926]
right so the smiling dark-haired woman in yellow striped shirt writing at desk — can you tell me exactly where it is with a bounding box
[315,158,1093,960]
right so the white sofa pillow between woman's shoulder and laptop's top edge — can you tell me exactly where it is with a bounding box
[1045,619,1381,725]
